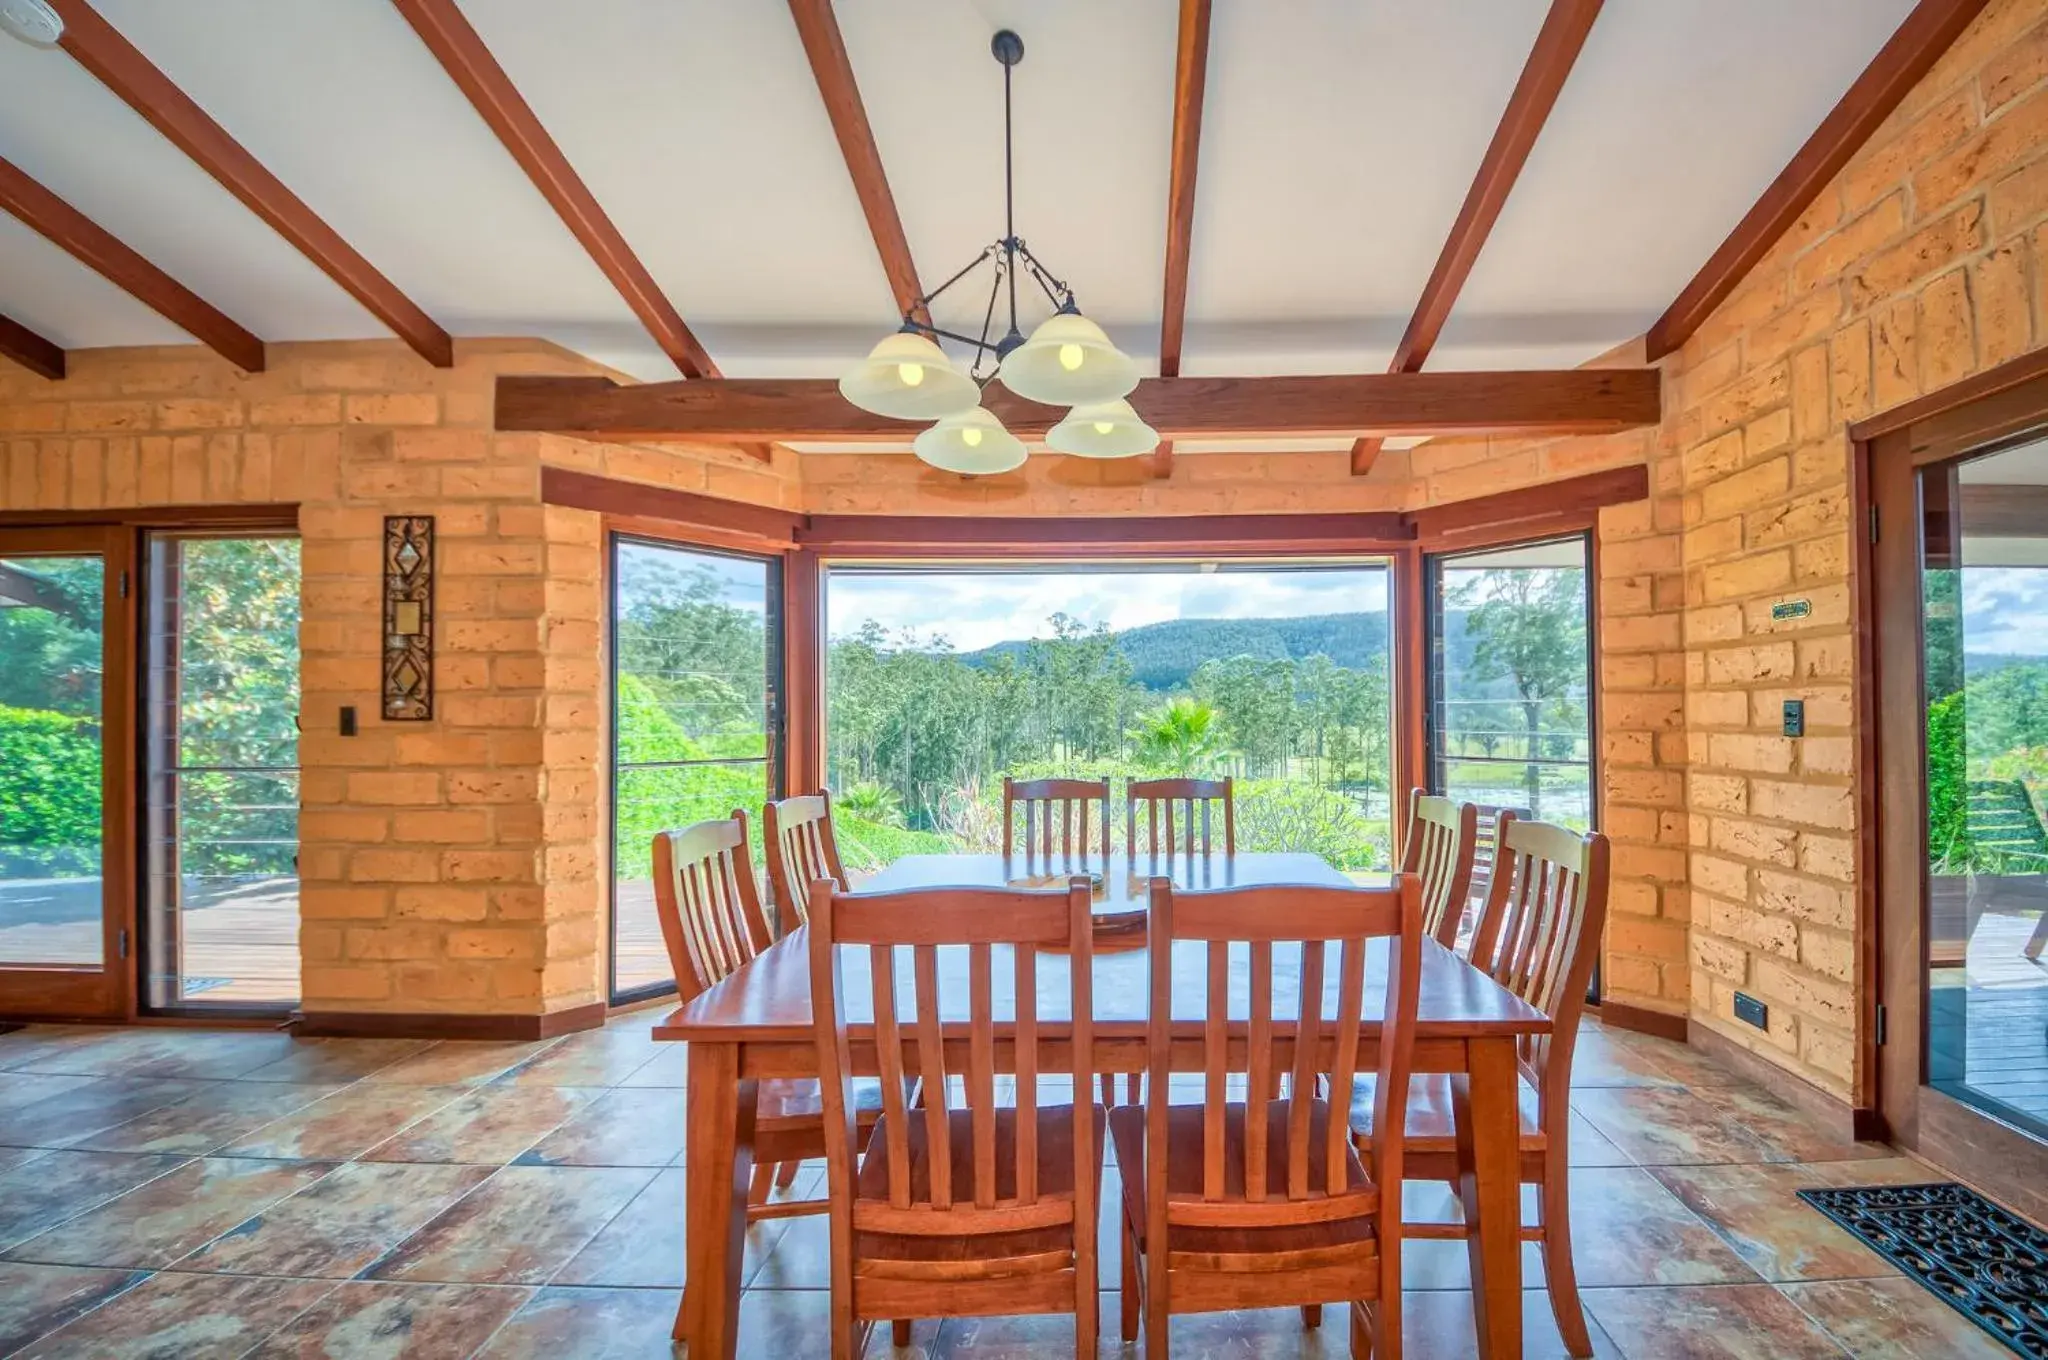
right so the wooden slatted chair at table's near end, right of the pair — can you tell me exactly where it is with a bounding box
[1110,875,1421,1360]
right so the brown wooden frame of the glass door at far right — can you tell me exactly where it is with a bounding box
[1849,356,2048,1221]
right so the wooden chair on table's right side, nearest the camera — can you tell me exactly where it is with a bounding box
[1352,813,1608,1356]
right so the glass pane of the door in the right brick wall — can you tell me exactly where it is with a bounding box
[1921,444,2048,1137]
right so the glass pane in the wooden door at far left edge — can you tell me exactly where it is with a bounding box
[0,557,106,967]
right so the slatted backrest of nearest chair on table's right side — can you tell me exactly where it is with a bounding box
[1473,815,1608,1100]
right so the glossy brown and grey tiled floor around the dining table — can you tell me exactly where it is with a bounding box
[0,1014,2007,1360]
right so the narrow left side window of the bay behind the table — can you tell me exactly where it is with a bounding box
[610,537,782,1002]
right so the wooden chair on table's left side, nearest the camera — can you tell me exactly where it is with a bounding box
[653,809,881,1221]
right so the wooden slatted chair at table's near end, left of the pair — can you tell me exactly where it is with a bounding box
[811,879,1106,1360]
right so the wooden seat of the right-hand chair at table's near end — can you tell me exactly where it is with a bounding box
[1110,1100,1378,1256]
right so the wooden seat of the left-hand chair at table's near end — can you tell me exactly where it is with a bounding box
[854,1104,1108,1262]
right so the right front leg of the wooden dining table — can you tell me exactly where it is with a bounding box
[1450,1038,1522,1360]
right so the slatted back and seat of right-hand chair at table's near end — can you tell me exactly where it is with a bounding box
[1145,875,1421,1241]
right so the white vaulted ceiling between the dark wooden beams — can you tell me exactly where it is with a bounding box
[0,0,1911,391]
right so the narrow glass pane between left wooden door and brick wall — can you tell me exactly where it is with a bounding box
[145,537,299,1008]
